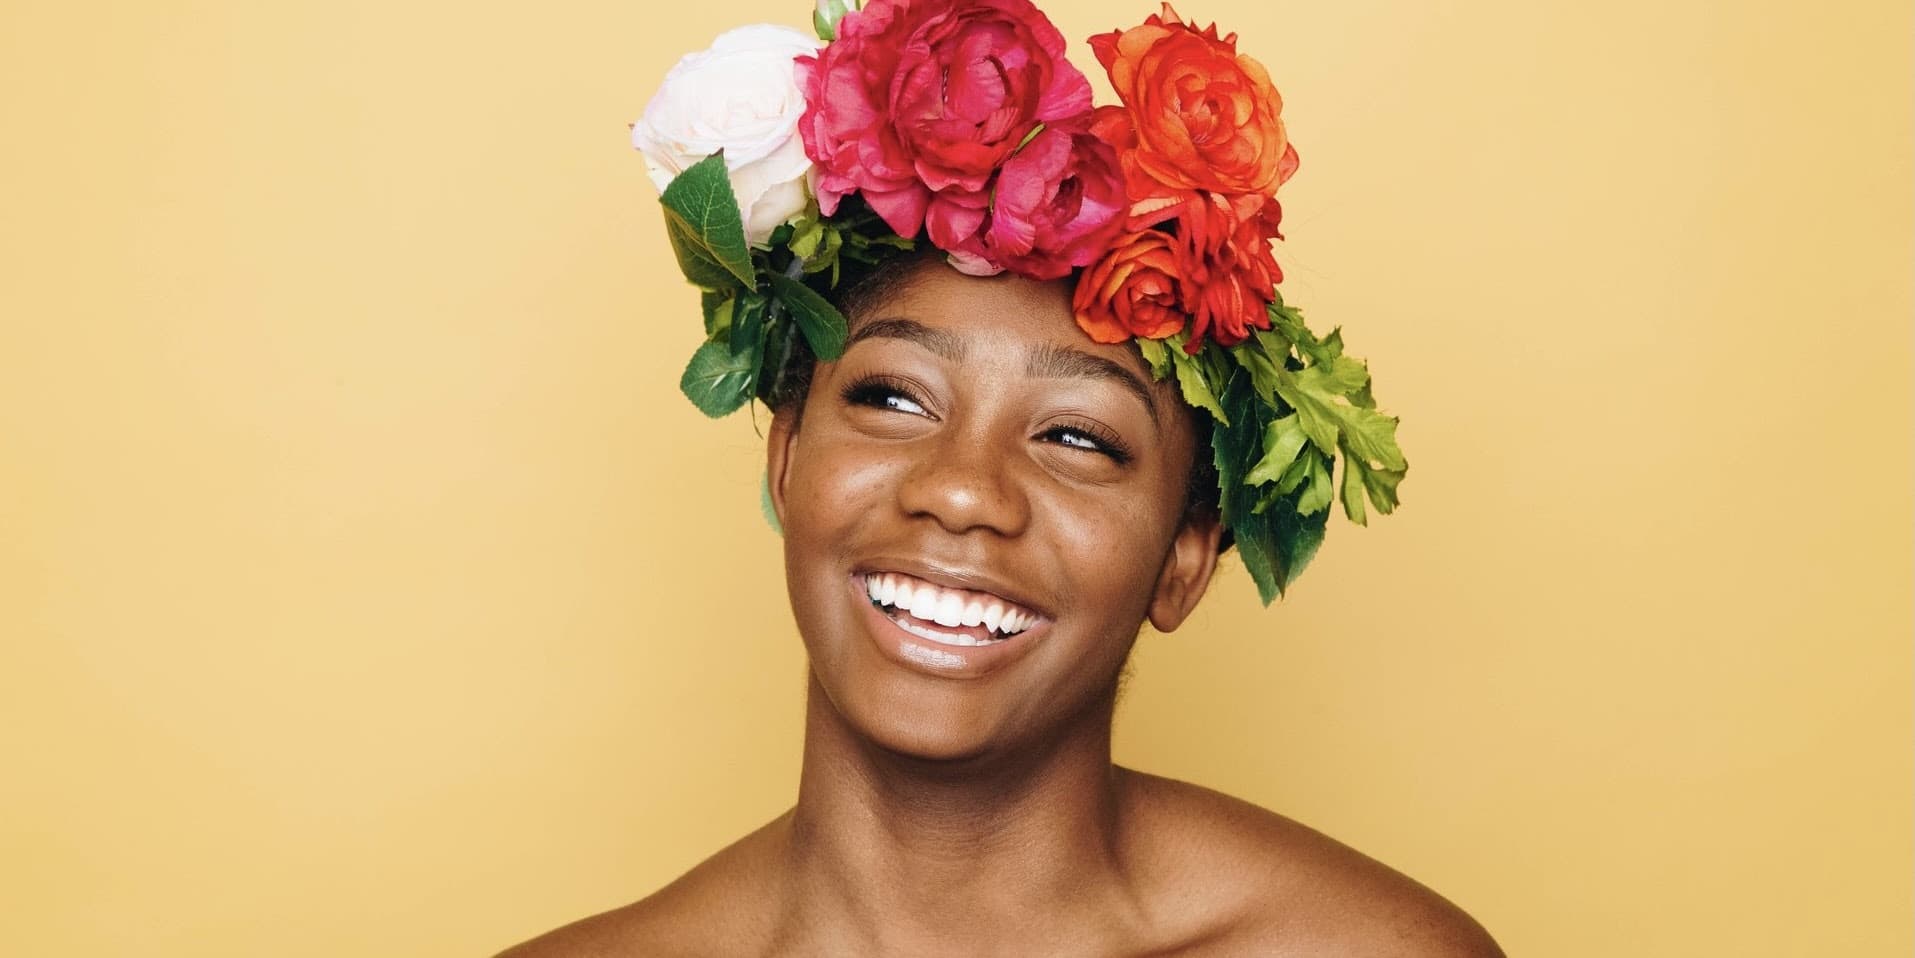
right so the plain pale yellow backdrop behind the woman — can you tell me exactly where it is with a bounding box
[0,0,1915,958]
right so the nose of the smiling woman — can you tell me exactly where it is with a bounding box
[898,429,1030,536]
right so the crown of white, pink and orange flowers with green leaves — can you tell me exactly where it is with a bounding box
[632,0,1408,605]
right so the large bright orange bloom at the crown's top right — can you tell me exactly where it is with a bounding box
[1090,4,1296,199]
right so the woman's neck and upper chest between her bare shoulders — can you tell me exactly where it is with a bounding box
[769,678,1136,954]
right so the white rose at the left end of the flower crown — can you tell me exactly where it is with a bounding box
[632,23,820,245]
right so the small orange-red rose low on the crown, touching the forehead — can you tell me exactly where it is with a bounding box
[1070,230,1189,343]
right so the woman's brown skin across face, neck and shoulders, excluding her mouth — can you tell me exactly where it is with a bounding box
[502,261,1501,958]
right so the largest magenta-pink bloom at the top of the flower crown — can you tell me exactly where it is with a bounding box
[799,0,1090,236]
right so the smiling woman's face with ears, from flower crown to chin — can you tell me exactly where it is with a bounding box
[770,261,1218,759]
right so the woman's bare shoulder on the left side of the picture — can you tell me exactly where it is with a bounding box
[498,812,789,958]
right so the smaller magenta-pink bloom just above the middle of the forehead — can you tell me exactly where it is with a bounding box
[927,126,1126,280]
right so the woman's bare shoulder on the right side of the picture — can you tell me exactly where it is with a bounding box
[1128,770,1503,958]
